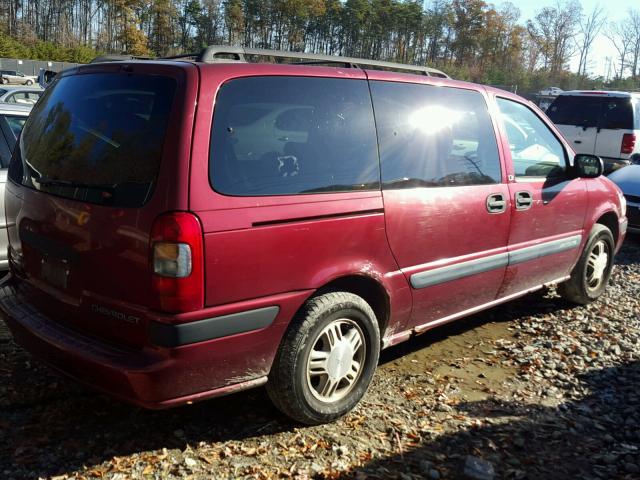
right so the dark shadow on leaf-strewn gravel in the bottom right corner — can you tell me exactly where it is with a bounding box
[349,362,640,480]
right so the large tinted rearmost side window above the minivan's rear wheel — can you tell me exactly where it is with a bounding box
[209,77,380,196]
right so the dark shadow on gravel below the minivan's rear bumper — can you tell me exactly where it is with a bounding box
[0,378,293,478]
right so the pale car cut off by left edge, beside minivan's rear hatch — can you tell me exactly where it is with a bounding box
[0,103,31,271]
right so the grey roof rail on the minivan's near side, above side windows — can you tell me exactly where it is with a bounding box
[195,45,449,78]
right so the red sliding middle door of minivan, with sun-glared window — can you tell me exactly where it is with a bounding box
[369,77,510,326]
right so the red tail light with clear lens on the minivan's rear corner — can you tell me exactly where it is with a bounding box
[151,212,204,313]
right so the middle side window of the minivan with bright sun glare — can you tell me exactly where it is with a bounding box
[371,81,501,189]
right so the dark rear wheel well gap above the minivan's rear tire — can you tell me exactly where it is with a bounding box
[316,275,390,337]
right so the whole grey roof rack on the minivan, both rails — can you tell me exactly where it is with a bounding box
[90,45,449,78]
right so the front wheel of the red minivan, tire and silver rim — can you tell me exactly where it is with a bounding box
[558,223,615,305]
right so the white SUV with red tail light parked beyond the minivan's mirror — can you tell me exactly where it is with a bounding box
[546,90,640,173]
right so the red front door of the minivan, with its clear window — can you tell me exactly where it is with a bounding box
[497,98,587,297]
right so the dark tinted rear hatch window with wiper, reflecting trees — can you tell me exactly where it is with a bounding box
[9,73,176,207]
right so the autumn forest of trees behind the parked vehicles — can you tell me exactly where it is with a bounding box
[0,0,640,90]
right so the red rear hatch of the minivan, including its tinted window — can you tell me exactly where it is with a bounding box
[6,63,197,346]
